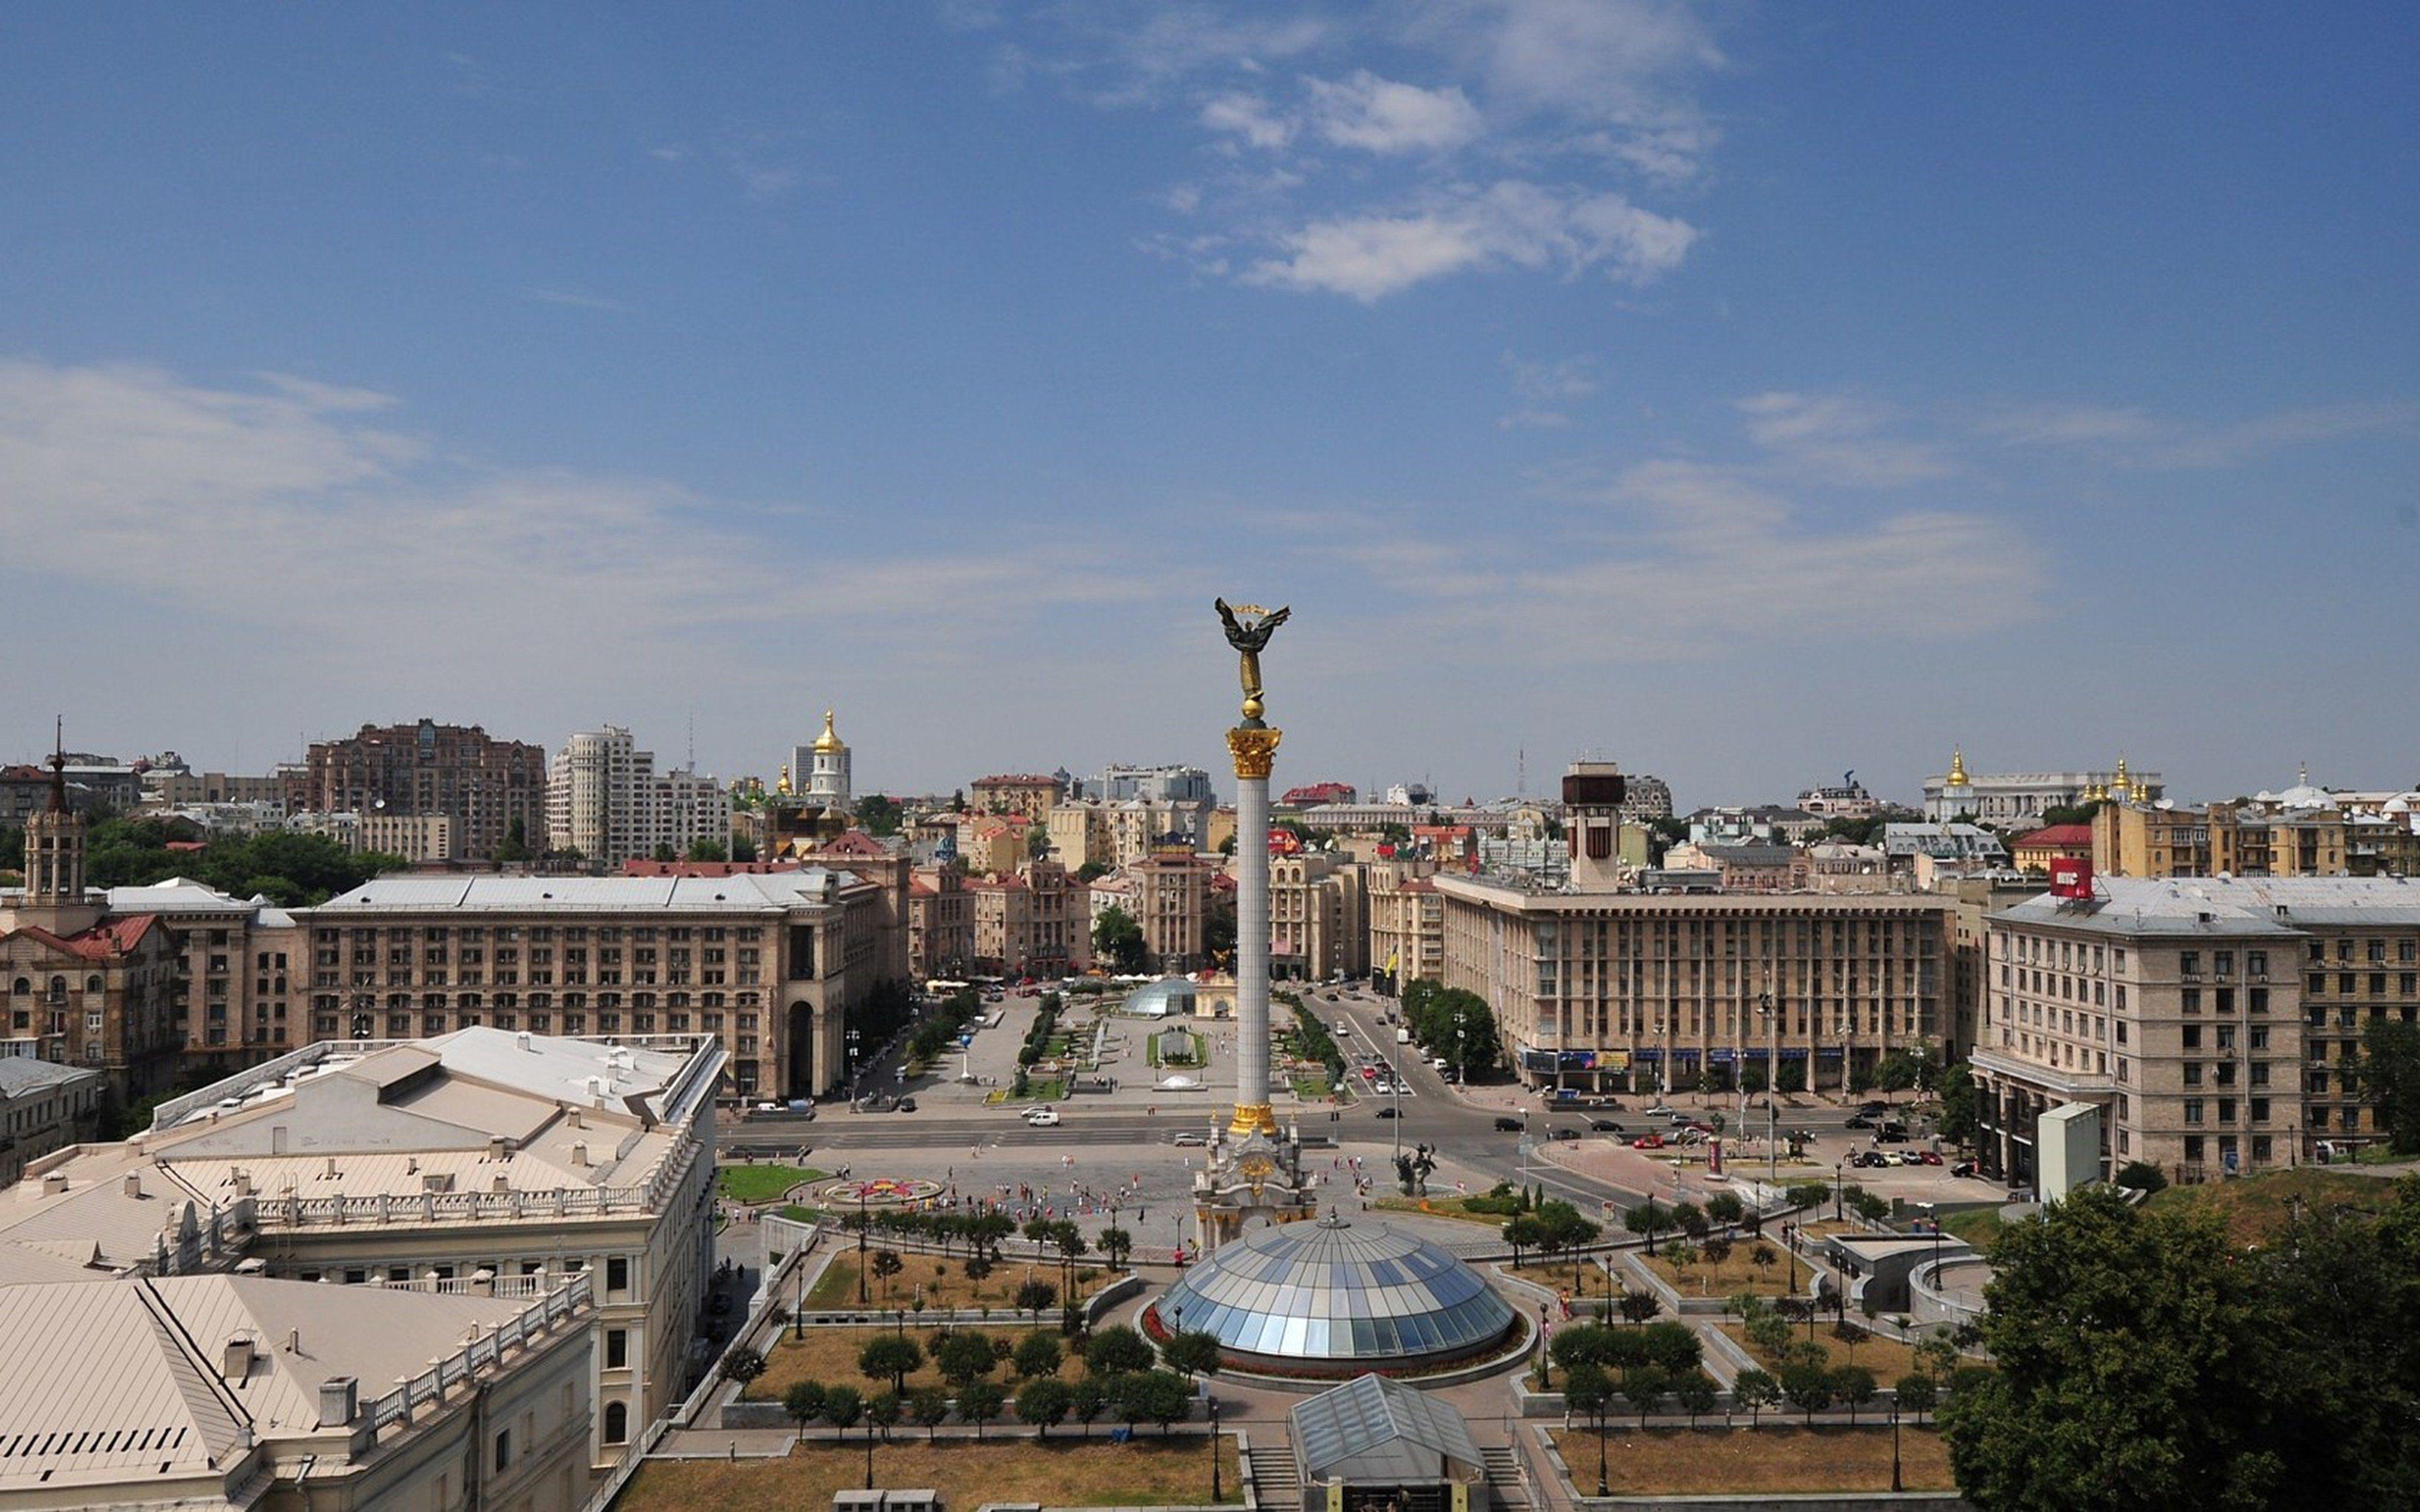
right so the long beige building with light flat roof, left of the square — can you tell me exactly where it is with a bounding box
[295,866,895,1101]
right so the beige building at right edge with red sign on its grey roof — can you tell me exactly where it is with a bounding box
[1972,876,2420,1183]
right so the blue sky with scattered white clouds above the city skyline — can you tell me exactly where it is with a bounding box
[0,0,2420,803]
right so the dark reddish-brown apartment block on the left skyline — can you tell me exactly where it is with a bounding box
[286,719,547,856]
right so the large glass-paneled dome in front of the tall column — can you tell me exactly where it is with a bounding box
[1145,1217,1520,1377]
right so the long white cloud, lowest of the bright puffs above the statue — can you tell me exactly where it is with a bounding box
[1244,179,1699,302]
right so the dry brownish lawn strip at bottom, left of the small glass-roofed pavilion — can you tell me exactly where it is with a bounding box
[615,1425,1239,1512]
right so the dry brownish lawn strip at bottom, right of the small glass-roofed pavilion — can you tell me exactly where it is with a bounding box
[1539,1422,1955,1495]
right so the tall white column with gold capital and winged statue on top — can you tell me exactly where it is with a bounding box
[1217,600,1290,1137]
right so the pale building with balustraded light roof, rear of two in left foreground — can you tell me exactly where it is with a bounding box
[0,1028,724,1468]
